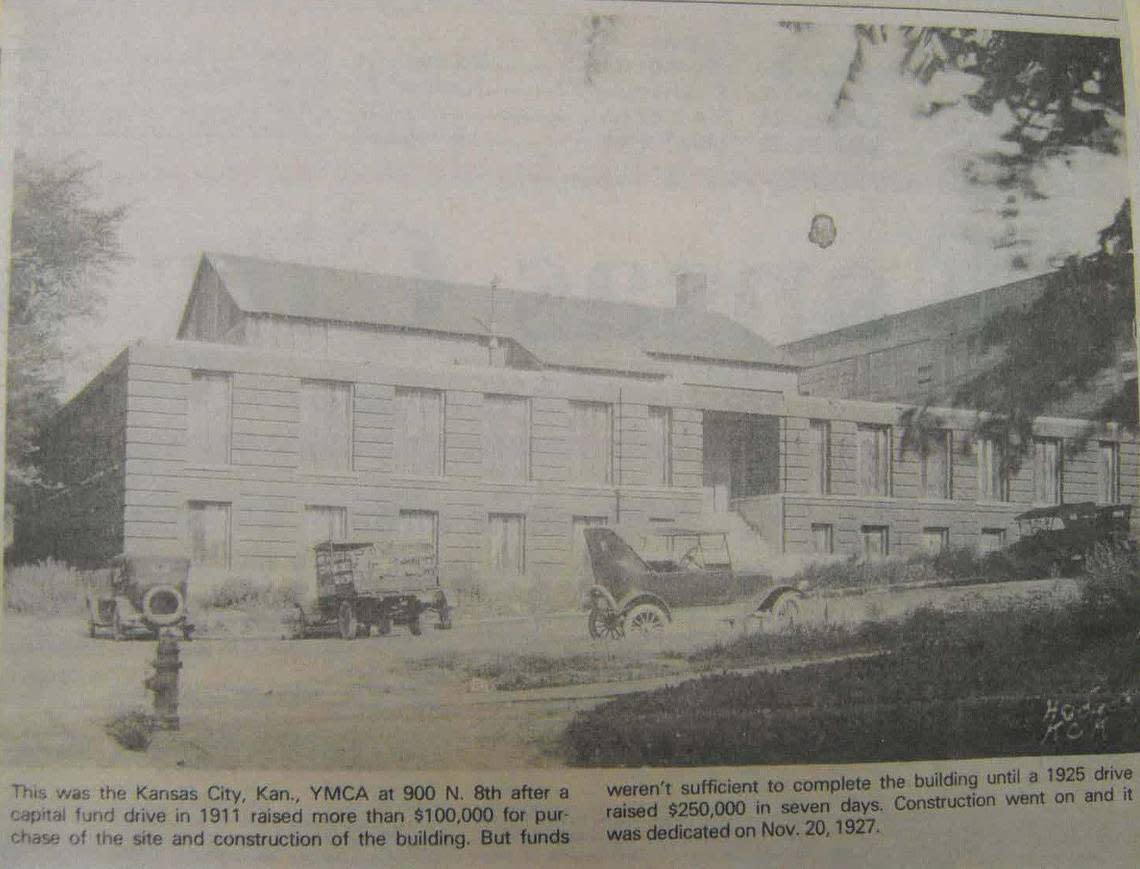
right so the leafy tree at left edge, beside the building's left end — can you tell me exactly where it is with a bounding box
[6,153,127,504]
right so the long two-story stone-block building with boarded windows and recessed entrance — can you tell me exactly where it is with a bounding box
[17,250,1140,607]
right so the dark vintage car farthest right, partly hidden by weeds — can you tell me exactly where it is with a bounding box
[1005,501,1133,576]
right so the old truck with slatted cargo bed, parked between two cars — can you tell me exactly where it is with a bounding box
[300,541,451,640]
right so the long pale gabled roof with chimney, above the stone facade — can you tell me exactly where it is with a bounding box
[186,253,793,373]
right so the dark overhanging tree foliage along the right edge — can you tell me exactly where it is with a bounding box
[836,25,1138,460]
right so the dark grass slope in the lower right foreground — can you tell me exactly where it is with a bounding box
[565,551,1140,766]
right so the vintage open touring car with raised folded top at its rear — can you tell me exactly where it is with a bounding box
[585,527,803,639]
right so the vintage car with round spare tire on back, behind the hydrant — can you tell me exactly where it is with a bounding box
[87,555,194,640]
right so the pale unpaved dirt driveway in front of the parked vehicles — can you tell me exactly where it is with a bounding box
[0,582,1073,770]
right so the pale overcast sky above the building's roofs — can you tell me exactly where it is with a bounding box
[5,0,1127,387]
